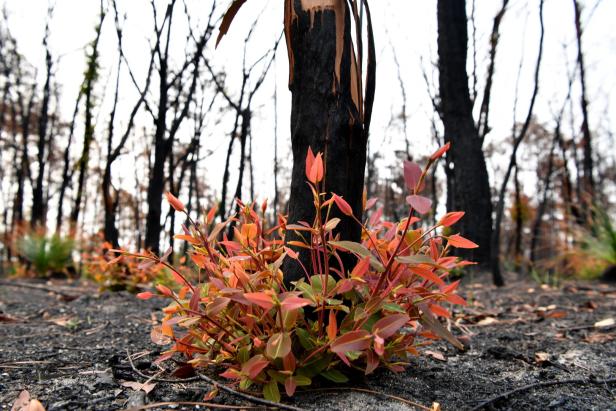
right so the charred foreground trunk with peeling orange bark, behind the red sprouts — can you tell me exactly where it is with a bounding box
[283,0,374,284]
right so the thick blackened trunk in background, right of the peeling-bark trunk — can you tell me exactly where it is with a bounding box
[437,0,494,272]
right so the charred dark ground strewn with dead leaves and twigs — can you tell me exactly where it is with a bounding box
[0,279,616,411]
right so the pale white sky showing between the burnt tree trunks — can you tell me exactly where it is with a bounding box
[0,0,616,237]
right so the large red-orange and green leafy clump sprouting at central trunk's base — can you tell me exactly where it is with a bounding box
[120,146,477,401]
